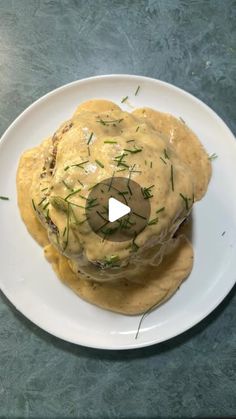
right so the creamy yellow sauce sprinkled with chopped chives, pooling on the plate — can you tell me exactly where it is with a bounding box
[17,100,211,314]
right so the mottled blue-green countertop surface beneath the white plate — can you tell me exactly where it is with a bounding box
[0,0,236,419]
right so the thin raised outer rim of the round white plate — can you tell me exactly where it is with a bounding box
[0,73,236,350]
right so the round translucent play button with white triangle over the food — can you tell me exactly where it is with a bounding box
[86,176,151,242]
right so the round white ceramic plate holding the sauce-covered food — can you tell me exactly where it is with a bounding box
[0,75,236,349]
